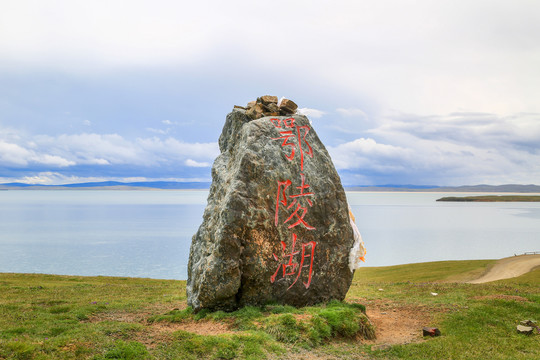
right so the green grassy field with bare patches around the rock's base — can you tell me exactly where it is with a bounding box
[0,261,540,360]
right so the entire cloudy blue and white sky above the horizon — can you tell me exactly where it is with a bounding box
[0,0,540,186]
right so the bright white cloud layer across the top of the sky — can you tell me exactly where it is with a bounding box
[0,0,540,119]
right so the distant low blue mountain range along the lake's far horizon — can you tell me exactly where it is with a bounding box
[0,181,540,193]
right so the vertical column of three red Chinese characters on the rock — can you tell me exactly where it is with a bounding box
[270,118,317,290]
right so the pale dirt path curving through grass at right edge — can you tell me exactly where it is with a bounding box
[468,255,540,284]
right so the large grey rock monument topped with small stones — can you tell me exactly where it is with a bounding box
[187,96,363,311]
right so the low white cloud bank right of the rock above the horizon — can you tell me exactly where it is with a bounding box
[328,113,540,185]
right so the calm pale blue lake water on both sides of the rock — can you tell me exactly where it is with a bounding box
[0,190,540,279]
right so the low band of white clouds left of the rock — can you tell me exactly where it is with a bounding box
[0,133,219,172]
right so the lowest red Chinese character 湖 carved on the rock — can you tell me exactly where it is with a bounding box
[270,234,317,290]
